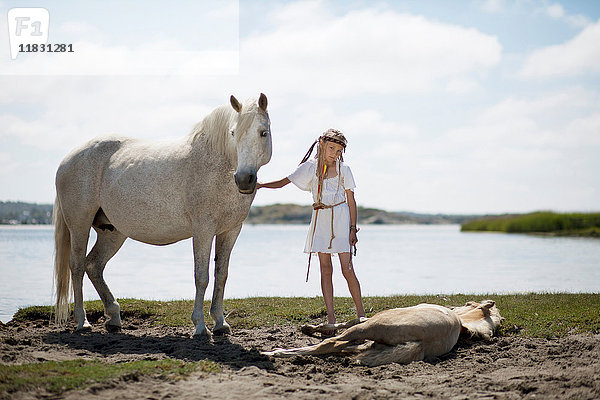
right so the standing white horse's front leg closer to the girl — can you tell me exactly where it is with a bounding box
[210,225,242,335]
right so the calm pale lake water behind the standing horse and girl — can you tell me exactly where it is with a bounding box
[0,225,600,322]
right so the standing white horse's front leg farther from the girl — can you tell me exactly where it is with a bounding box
[192,233,213,337]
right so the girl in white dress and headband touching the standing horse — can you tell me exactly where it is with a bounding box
[257,129,365,326]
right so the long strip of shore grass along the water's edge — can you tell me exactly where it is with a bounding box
[15,293,600,337]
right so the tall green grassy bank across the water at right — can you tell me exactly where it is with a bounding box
[460,211,600,237]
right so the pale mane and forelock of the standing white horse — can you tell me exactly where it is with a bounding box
[190,99,268,160]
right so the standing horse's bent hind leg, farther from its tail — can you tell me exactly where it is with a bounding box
[85,229,127,332]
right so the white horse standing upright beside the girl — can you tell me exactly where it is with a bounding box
[53,93,272,336]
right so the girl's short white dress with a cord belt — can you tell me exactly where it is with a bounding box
[288,159,356,253]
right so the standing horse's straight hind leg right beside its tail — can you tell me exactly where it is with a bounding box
[69,226,92,331]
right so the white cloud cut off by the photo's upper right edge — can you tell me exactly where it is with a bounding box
[520,21,600,78]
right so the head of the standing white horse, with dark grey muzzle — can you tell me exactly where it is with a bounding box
[230,93,272,194]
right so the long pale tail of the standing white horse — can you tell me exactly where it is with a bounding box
[52,196,72,326]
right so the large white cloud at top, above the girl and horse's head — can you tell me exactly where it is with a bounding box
[241,1,502,97]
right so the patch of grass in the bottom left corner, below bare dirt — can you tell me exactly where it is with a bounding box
[0,359,221,394]
